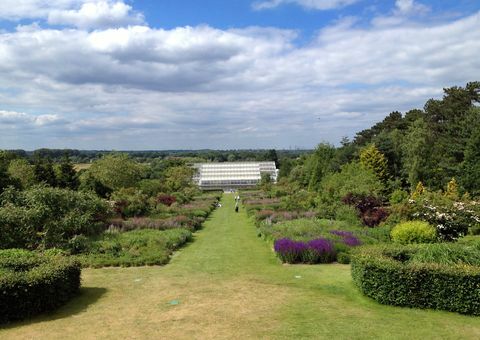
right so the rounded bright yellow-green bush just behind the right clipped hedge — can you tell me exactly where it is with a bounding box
[391,221,437,244]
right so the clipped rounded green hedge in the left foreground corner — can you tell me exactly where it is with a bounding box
[0,249,81,323]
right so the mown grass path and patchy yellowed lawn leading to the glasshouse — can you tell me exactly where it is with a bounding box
[0,195,480,339]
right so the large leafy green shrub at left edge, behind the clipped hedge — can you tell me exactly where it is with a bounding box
[0,186,110,249]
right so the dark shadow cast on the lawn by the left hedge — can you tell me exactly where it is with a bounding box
[0,287,107,329]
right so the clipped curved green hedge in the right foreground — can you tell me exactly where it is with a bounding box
[352,245,480,315]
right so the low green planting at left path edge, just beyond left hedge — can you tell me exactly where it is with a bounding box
[76,228,192,268]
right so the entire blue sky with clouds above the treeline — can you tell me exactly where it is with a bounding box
[0,0,480,150]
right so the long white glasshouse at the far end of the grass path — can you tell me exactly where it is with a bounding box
[194,162,278,190]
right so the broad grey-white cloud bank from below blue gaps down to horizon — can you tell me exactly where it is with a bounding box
[0,2,480,149]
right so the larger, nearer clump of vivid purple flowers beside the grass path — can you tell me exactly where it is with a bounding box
[274,238,336,264]
